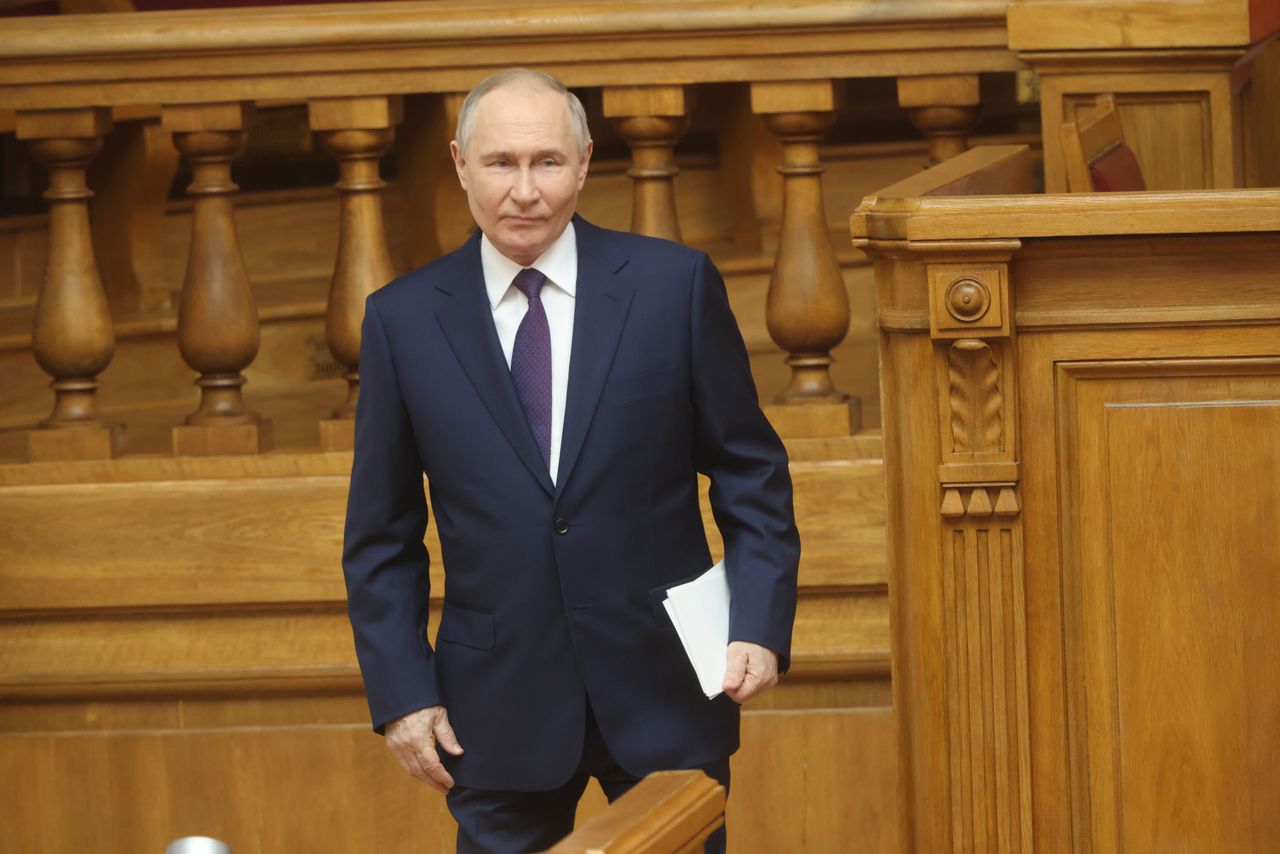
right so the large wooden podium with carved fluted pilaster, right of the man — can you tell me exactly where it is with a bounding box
[852,146,1280,854]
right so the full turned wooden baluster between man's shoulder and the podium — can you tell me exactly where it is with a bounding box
[751,81,860,438]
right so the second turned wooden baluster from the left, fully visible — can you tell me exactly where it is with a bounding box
[164,104,270,456]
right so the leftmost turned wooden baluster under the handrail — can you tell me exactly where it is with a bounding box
[17,108,123,461]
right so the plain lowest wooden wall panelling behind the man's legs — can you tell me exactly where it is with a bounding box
[0,704,897,854]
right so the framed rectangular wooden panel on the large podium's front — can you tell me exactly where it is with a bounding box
[1060,360,1280,853]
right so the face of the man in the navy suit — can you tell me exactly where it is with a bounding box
[449,86,591,266]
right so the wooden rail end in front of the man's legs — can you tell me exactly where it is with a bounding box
[549,771,724,854]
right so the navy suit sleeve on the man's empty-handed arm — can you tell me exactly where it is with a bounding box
[342,297,440,734]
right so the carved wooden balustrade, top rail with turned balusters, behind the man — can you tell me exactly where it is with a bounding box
[0,0,1020,458]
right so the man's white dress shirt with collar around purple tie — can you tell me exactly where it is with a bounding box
[480,222,577,483]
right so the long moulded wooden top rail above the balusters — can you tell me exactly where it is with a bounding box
[0,0,1023,110]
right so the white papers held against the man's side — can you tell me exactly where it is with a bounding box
[663,561,728,698]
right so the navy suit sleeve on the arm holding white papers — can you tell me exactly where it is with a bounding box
[690,255,800,671]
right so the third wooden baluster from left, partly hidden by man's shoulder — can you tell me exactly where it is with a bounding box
[308,96,403,451]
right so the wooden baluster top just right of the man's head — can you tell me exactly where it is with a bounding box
[604,86,694,243]
